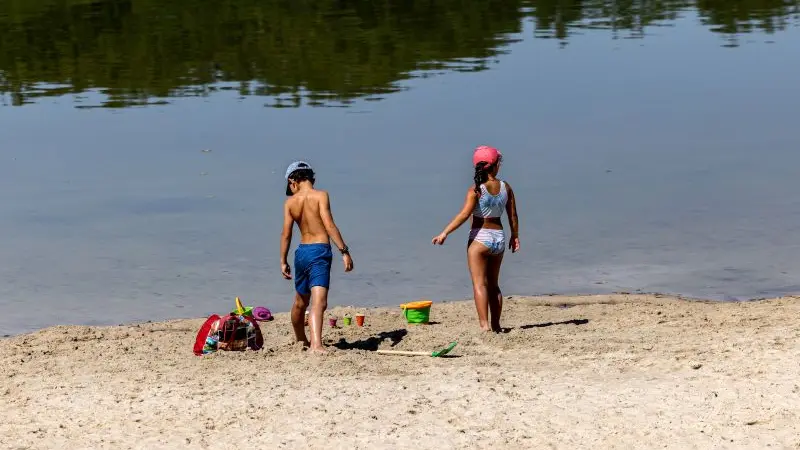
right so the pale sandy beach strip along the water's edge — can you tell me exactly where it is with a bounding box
[0,295,800,449]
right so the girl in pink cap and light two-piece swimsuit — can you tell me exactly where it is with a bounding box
[433,145,519,332]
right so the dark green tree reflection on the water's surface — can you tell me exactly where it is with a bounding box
[0,0,800,107]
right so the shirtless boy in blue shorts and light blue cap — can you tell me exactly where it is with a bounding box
[281,161,353,353]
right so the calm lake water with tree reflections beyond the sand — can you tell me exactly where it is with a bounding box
[0,0,800,334]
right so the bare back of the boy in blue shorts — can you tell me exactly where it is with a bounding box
[285,189,333,244]
